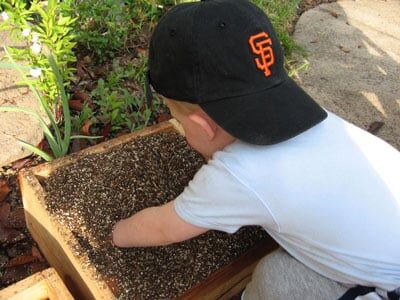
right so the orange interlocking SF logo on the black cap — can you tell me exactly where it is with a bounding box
[249,32,275,77]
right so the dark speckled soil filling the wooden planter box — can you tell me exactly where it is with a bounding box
[44,133,266,299]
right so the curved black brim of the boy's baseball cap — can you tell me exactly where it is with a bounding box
[200,78,327,145]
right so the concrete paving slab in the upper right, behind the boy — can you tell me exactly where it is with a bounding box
[294,0,400,149]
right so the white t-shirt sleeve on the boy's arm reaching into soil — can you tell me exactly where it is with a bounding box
[174,160,269,233]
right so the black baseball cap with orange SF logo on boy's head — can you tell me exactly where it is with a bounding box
[148,0,327,145]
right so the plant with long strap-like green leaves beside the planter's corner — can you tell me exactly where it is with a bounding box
[0,47,99,161]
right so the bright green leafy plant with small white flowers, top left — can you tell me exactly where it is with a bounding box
[0,0,76,108]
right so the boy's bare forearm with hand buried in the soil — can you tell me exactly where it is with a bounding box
[112,201,208,247]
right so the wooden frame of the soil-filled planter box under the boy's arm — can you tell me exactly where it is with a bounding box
[19,120,277,300]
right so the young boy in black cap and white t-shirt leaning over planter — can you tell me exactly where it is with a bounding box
[113,0,400,299]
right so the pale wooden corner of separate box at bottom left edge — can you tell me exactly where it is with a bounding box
[0,268,74,300]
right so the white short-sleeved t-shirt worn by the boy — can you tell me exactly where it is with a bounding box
[175,112,400,290]
